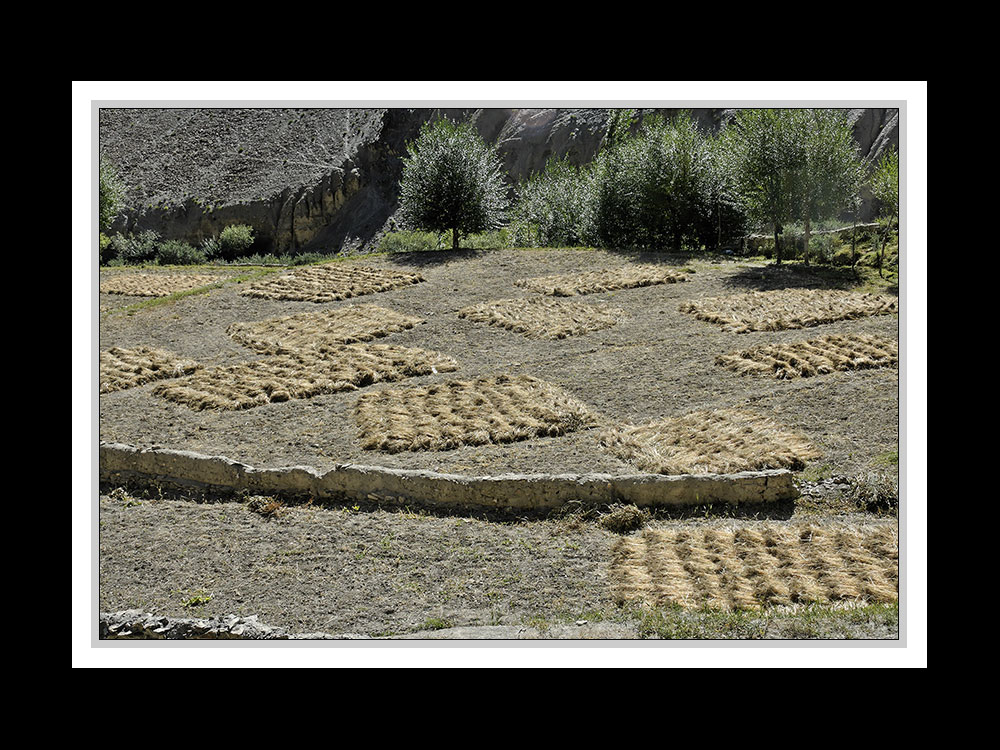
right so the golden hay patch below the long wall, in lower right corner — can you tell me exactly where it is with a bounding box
[612,522,899,610]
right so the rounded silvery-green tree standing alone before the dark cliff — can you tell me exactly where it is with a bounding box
[399,119,507,250]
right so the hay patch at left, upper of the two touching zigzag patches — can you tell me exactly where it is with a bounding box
[227,305,423,354]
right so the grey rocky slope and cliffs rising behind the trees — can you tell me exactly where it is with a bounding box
[99,108,899,252]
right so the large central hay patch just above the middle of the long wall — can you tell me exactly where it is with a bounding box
[355,375,595,453]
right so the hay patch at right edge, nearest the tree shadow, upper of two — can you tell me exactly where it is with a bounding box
[680,289,898,333]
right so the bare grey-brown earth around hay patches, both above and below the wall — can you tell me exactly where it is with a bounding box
[100,251,899,638]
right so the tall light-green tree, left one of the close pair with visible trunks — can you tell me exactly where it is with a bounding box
[724,109,800,264]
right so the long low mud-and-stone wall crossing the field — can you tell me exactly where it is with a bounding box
[100,443,798,510]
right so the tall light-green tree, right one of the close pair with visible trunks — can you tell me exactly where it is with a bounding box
[790,109,862,263]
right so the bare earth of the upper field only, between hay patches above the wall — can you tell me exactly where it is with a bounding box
[100,250,899,475]
